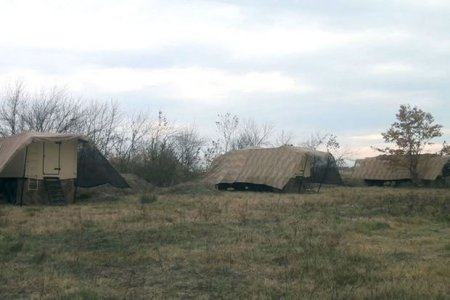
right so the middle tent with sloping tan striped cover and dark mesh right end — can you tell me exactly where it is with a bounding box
[205,146,342,192]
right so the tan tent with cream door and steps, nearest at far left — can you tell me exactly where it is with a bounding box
[0,132,128,204]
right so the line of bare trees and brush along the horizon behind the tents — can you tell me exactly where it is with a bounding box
[0,81,450,186]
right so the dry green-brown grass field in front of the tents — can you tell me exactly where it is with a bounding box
[0,188,450,299]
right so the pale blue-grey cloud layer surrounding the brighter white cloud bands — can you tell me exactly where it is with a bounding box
[0,0,450,154]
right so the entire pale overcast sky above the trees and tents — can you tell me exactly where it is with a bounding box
[0,0,450,157]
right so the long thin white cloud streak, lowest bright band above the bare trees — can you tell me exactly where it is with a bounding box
[74,66,312,102]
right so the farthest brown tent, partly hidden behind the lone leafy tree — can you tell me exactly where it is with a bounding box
[352,154,450,185]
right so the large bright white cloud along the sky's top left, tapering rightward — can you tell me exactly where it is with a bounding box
[0,0,386,59]
